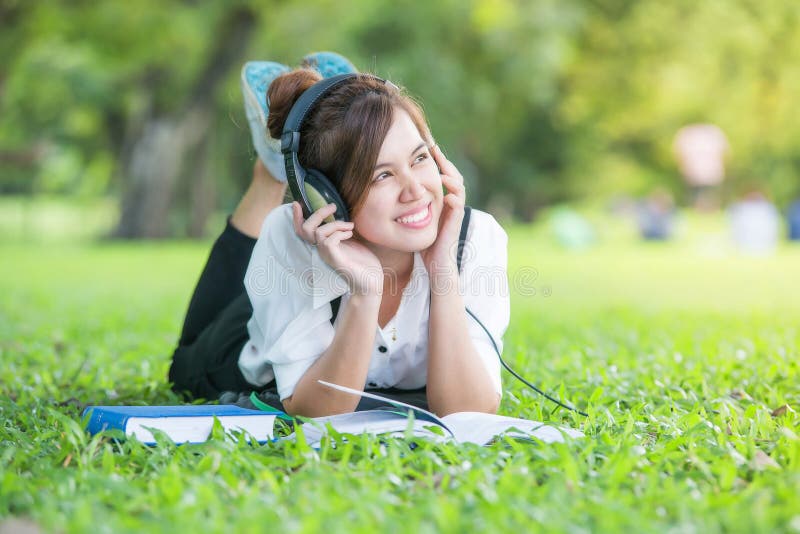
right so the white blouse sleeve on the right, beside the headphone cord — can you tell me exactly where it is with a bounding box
[459,209,511,395]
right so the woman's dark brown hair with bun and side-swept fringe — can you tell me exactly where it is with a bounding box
[267,69,432,216]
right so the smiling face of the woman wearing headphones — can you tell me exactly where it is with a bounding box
[353,108,443,258]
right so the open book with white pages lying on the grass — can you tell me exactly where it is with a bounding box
[296,380,583,447]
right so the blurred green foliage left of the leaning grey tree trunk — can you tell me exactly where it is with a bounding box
[0,2,244,202]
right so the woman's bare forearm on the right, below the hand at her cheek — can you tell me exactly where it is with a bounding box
[427,272,500,416]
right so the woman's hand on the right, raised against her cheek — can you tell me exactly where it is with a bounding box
[420,145,466,283]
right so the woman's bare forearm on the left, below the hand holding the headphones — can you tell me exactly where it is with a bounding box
[283,294,381,417]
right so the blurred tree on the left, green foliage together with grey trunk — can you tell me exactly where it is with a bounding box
[0,0,257,237]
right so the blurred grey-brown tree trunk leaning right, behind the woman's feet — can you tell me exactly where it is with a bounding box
[113,8,255,239]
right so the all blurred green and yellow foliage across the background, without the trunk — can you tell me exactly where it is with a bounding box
[0,0,800,224]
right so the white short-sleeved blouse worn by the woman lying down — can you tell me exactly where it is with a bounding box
[239,204,510,400]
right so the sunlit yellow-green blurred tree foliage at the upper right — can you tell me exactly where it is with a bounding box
[559,0,800,205]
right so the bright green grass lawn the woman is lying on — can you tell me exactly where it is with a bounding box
[0,219,800,532]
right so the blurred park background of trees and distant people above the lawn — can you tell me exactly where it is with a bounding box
[0,0,800,247]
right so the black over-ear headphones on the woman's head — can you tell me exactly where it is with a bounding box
[281,74,395,222]
